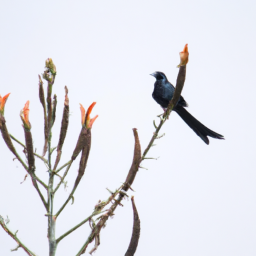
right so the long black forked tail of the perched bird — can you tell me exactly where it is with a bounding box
[174,106,224,145]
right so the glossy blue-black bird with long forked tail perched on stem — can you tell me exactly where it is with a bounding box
[151,72,224,145]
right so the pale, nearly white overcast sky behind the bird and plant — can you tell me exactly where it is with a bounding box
[0,0,256,256]
